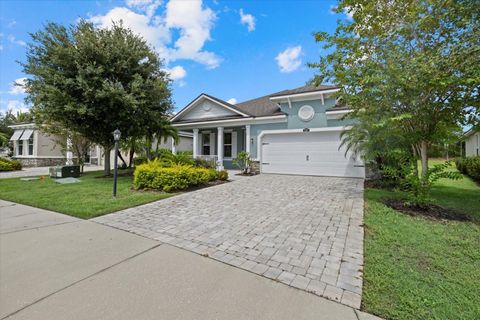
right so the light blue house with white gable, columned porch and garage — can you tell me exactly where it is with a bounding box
[171,86,365,178]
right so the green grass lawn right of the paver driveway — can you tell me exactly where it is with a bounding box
[362,161,480,319]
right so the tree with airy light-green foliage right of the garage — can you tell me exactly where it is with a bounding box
[310,0,480,202]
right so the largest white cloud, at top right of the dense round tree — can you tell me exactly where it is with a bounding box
[90,0,221,69]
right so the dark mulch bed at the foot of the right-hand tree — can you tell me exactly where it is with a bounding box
[384,199,473,221]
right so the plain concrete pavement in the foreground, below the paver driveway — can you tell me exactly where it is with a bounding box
[0,201,374,320]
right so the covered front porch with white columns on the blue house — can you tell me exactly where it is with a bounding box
[172,125,252,170]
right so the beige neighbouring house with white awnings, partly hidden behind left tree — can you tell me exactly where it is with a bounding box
[10,123,193,167]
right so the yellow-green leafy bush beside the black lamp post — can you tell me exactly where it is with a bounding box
[133,159,218,192]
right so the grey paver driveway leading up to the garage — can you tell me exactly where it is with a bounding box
[93,175,363,308]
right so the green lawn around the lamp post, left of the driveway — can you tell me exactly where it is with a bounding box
[0,172,173,219]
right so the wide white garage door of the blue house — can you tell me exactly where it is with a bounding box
[261,131,365,178]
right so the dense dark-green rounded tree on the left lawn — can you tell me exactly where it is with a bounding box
[23,21,172,175]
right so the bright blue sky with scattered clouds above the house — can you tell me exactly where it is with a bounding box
[0,0,348,111]
